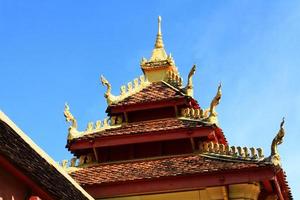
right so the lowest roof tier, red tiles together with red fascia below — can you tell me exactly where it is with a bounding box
[70,154,291,199]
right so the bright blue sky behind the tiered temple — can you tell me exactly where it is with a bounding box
[0,0,300,199]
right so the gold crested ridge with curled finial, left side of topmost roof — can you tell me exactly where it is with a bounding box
[101,75,150,105]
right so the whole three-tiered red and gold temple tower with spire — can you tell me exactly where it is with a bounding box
[62,17,292,200]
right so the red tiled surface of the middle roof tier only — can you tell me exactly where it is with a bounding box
[73,118,209,141]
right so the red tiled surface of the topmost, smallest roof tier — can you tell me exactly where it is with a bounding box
[111,81,185,107]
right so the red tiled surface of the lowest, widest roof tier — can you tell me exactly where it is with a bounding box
[70,155,268,185]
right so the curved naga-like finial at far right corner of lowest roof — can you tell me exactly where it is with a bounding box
[268,118,285,166]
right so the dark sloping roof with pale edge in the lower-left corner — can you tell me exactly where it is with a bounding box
[0,111,93,200]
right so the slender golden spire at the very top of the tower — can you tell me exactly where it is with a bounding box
[149,16,168,61]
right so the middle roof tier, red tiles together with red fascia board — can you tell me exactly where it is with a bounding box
[67,118,227,152]
